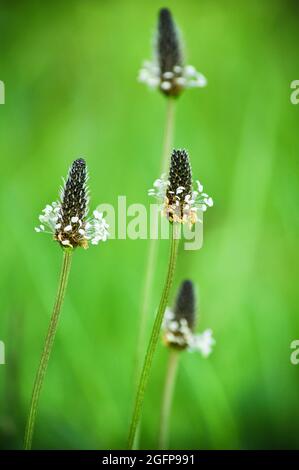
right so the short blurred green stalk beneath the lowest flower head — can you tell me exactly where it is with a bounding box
[159,349,180,450]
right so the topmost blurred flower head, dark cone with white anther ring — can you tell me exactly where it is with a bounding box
[139,8,207,96]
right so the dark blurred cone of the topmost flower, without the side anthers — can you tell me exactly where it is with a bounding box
[157,8,183,96]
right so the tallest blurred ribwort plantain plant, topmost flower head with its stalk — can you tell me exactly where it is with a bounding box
[137,8,207,382]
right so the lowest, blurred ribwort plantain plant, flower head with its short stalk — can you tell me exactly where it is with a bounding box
[159,280,215,450]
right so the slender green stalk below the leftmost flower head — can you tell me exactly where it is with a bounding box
[24,248,72,450]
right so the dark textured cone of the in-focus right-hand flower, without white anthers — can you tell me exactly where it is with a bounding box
[166,150,192,220]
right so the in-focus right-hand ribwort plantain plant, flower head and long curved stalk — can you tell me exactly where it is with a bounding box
[128,150,212,449]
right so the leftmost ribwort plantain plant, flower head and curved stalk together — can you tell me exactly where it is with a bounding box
[24,158,108,450]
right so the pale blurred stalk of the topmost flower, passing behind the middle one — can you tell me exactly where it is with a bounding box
[136,97,175,377]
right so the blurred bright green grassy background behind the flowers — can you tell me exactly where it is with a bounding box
[0,0,299,449]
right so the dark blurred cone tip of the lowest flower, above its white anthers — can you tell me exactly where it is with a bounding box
[174,280,196,331]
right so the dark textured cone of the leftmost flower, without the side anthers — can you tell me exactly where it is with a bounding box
[55,158,88,248]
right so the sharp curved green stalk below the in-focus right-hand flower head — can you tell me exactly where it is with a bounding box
[128,224,179,449]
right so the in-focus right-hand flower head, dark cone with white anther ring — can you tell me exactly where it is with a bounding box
[148,150,213,225]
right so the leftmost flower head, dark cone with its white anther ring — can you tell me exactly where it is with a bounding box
[35,158,108,248]
